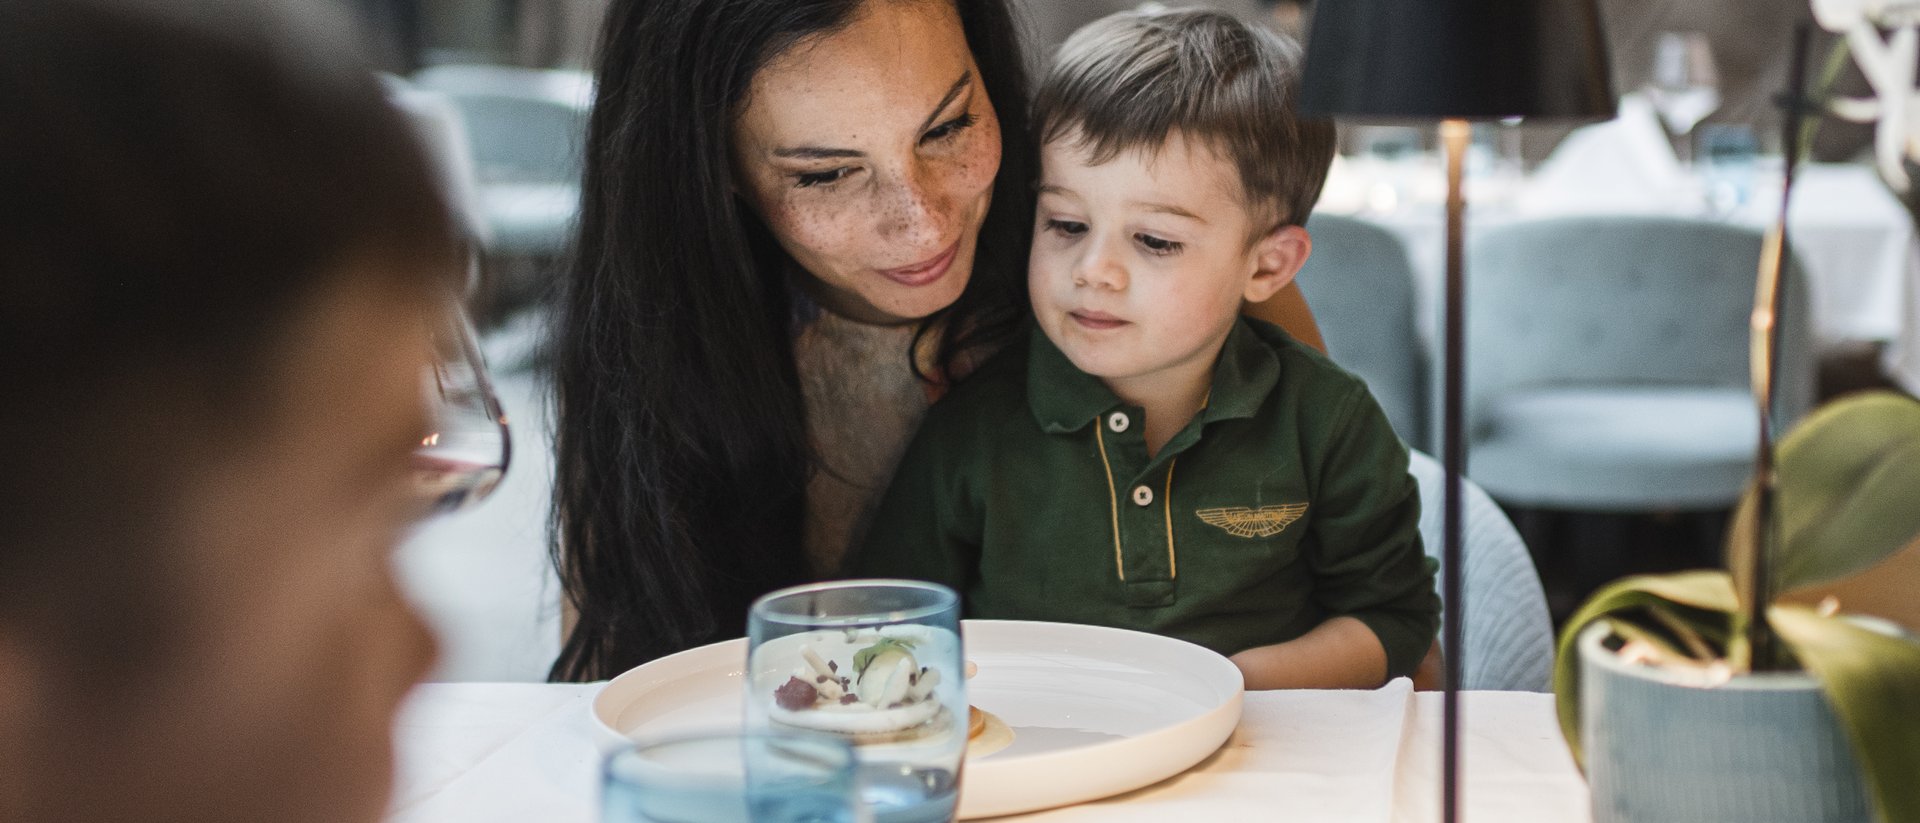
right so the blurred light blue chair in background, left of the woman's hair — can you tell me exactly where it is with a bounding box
[413,65,593,257]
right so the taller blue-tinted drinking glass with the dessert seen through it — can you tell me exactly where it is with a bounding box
[747,579,970,823]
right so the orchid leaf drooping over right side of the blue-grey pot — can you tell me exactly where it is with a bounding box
[1768,606,1920,821]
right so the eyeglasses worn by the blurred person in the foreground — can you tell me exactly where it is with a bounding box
[413,291,513,514]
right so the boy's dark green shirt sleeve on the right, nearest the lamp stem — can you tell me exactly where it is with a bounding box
[1308,388,1440,677]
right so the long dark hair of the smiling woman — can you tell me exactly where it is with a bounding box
[551,0,1035,681]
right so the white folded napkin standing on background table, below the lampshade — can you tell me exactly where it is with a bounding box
[1515,94,1699,215]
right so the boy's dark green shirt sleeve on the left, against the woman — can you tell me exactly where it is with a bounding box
[845,407,981,595]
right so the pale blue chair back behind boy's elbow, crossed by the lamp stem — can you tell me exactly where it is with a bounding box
[1407,451,1553,691]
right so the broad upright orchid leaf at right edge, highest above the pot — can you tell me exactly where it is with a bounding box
[1728,391,1920,600]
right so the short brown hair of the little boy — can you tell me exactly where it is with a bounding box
[1033,10,1334,228]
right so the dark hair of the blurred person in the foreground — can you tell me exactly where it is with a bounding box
[0,0,459,666]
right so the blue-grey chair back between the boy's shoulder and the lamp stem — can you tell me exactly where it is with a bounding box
[1296,215,1428,449]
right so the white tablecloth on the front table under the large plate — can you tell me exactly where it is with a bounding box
[392,679,1590,823]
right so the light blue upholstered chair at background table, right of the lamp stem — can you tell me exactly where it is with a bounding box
[1467,217,1814,512]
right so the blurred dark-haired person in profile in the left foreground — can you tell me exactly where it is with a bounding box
[0,0,459,823]
